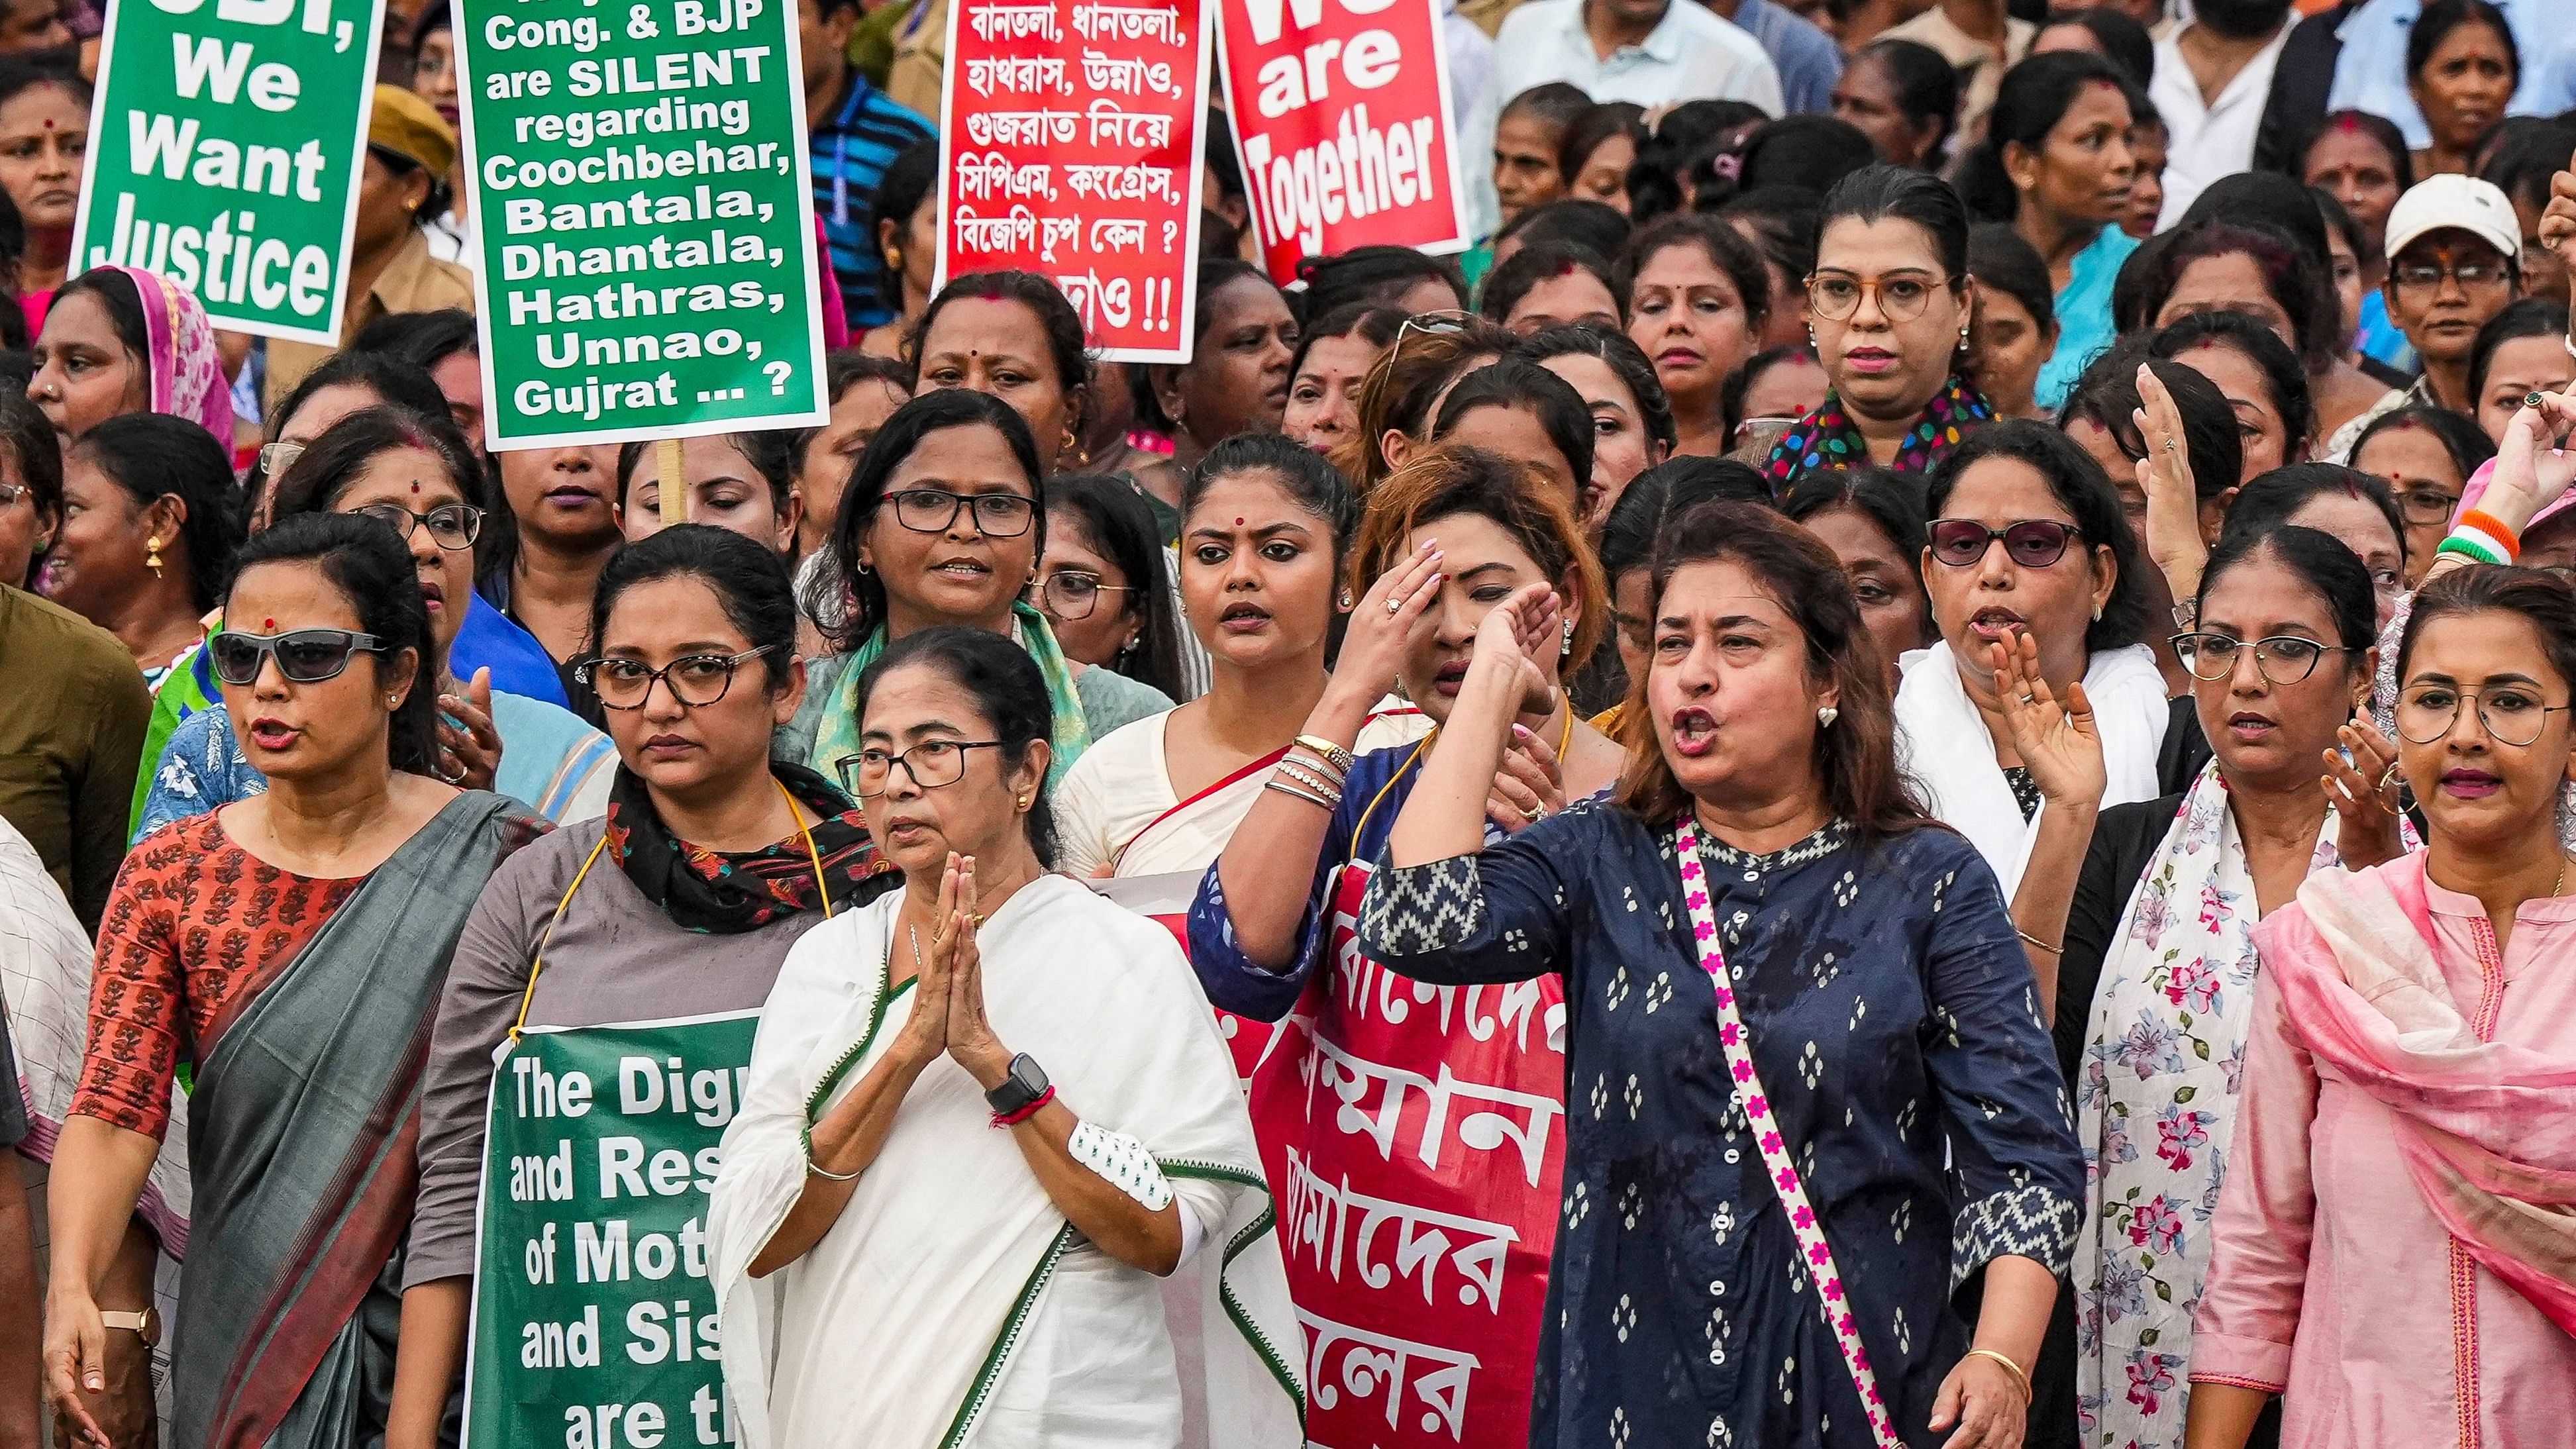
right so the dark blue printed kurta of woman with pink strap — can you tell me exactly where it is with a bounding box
[1360,803,2084,1449]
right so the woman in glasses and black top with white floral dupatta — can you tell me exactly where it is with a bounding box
[2004,528,2401,1446]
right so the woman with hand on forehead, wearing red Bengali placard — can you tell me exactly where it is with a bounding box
[1188,445,1620,1444]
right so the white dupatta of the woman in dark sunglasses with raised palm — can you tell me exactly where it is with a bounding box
[1896,641,2171,901]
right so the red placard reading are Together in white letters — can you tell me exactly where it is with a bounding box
[1218,0,1468,285]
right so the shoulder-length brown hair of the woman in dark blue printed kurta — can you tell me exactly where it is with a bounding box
[1610,502,1935,842]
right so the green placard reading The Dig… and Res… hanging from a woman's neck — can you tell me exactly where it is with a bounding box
[464,1014,760,1449]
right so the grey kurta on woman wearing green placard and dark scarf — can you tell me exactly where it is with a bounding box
[402,821,835,1287]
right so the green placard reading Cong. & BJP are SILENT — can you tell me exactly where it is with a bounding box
[456,0,829,448]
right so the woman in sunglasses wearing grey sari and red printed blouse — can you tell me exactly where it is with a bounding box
[44,515,544,1449]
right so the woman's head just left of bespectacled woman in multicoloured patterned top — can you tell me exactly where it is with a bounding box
[1613,214,1770,458]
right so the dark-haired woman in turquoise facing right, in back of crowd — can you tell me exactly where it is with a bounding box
[1961,52,2138,412]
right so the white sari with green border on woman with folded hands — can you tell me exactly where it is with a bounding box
[708,875,1306,1449]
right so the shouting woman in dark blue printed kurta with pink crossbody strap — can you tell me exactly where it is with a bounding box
[1358,505,2084,1449]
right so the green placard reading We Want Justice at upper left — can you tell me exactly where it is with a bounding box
[72,0,384,348]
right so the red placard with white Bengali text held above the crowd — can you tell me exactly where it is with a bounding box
[935,0,1211,363]
